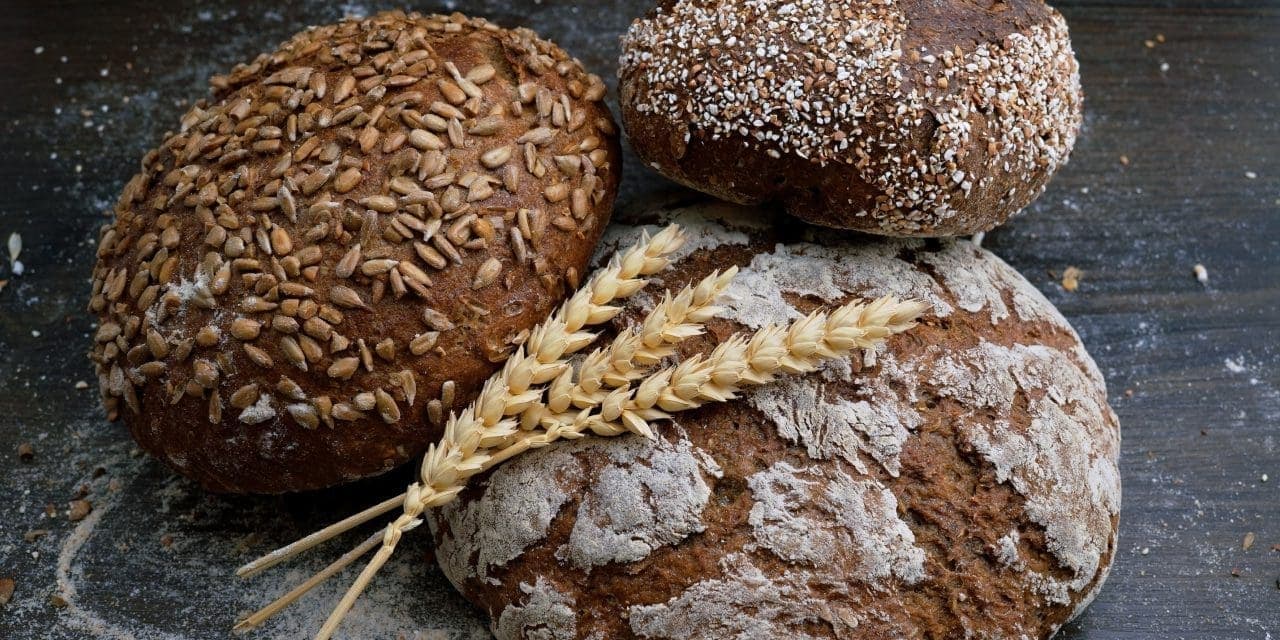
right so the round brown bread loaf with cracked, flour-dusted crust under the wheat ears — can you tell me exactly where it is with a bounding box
[431,209,1120,640]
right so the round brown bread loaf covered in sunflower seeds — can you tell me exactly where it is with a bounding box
[90,13,621,493]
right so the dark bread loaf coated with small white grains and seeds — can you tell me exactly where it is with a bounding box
[618,0,1083,236]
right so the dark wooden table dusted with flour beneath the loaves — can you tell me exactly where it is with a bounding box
[0,0,1280,640]
